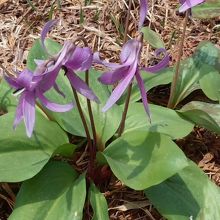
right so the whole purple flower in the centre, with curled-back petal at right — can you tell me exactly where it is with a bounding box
[94,39,169,117]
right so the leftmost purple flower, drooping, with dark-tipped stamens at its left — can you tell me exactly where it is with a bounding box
[5,69,73,137]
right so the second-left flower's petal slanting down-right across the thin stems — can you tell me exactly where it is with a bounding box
[66,70,99,103]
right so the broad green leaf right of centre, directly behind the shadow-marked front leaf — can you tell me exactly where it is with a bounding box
[124,103,194,139]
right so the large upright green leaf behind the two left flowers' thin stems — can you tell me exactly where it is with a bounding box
[28,40,121,143]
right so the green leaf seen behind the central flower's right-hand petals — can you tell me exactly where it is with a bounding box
[118,68,173,105]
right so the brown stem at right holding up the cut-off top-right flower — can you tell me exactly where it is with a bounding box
[167,10,189,108]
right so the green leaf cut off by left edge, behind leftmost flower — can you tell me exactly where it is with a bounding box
[0,79,17,112]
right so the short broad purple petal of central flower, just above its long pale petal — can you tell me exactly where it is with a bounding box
[99,66,129,85]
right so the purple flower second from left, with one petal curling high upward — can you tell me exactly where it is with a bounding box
[41,20,99,102]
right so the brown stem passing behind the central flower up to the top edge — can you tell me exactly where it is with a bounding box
[118,0,132,137]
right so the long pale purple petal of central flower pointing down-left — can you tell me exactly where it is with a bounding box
[102,62,137,112]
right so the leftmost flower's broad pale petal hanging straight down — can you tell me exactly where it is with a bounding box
[23,92,35,137]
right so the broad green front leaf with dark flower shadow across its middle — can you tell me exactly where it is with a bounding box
[103,131,188,190]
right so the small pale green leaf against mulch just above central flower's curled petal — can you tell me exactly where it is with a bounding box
[141,27,165,48]
